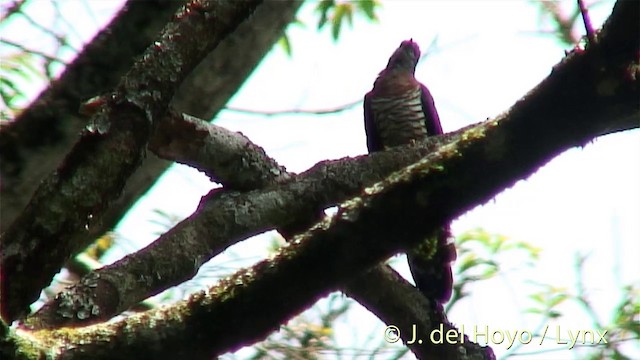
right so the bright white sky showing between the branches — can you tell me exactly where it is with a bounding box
[2,0,640,359]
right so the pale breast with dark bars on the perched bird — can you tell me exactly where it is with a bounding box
[371,88,428,148]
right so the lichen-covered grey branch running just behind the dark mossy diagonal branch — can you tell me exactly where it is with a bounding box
[29,114,453,327]
